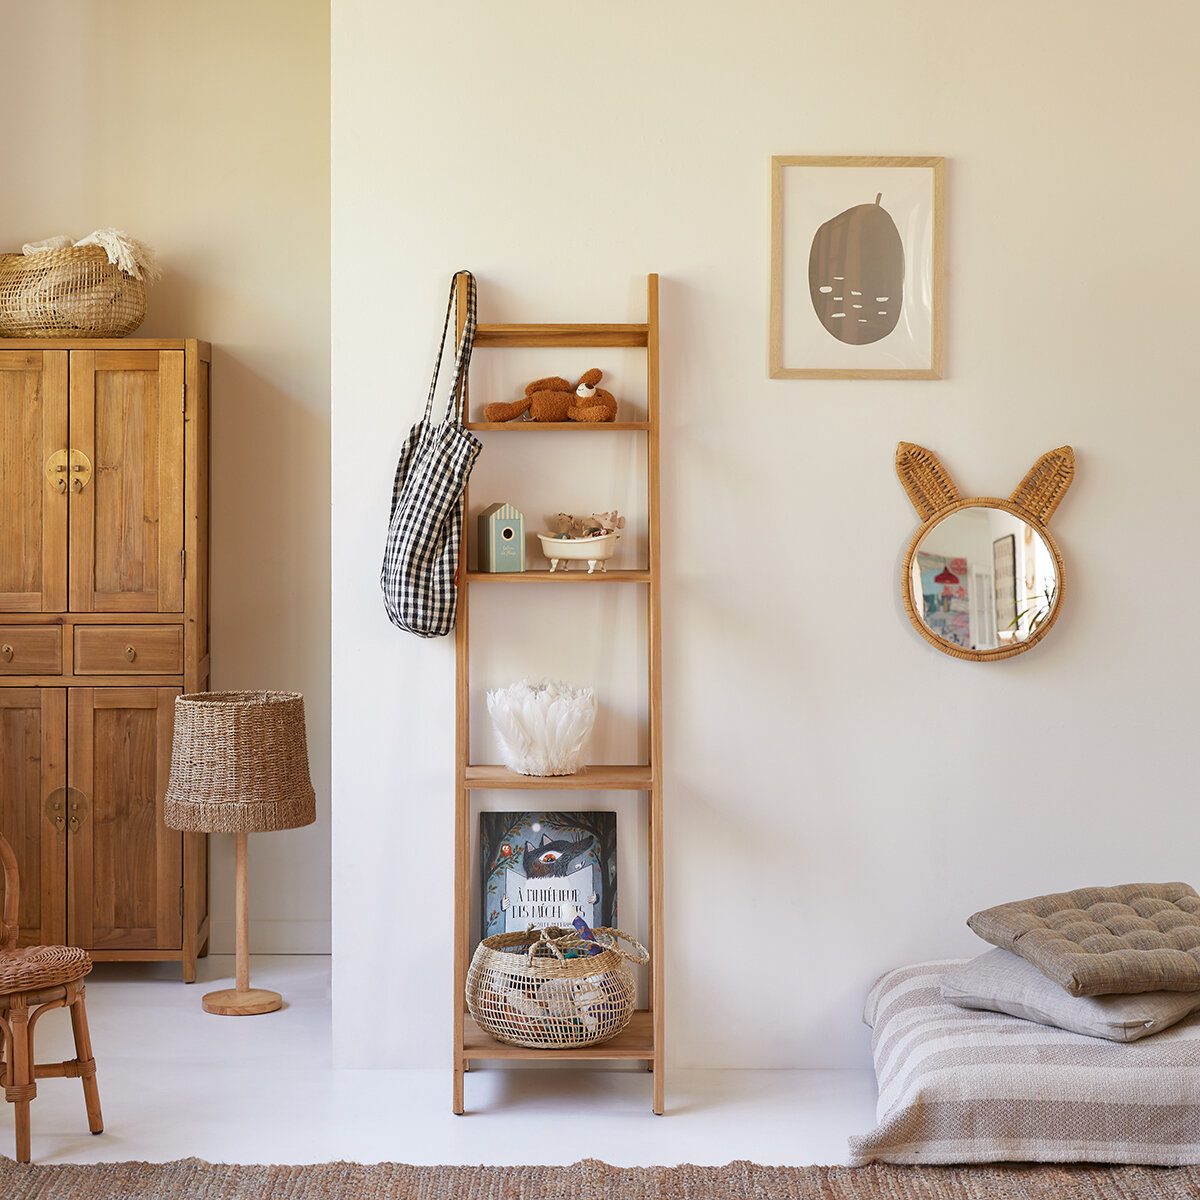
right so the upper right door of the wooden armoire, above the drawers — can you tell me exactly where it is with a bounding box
[71,350,184,613]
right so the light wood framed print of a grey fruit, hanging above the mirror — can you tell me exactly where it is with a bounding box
[769,155,944,379]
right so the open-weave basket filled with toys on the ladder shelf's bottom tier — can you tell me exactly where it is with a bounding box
[467,926,650,1050]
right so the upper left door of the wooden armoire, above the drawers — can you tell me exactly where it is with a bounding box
[0,350,67,612]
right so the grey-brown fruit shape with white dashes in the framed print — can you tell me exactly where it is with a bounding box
[809,192,904,346]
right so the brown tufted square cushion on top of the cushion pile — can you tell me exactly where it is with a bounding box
[967,883,1200,996]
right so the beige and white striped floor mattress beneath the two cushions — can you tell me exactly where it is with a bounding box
[850,959,1200,1166]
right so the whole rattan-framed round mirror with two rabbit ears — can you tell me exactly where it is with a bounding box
[896,442,1075,662]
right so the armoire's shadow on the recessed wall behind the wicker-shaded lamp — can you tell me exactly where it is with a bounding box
[202,344,330,953]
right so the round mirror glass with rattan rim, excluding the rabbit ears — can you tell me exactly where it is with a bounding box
[907,504,1061,658]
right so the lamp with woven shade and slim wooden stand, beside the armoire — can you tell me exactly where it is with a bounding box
[164,691,317,1016]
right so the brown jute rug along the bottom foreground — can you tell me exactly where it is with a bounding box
[0,1158,1200,1200]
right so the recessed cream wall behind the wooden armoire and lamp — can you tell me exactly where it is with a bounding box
[0,0,330,953]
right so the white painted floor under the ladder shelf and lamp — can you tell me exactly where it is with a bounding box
[0,955,875,1166]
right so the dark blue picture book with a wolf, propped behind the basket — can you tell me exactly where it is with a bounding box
[479,812,617,937]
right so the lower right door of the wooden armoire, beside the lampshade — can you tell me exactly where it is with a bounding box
[67,688,182,950]
